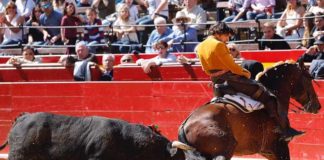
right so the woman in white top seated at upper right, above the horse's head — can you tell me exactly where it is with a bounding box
[276,0,305,39]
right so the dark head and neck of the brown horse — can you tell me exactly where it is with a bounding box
[259,61,321,113]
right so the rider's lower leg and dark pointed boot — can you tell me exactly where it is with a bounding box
[265,98,305,141]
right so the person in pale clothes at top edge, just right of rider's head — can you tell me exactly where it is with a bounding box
[223,0,251,22]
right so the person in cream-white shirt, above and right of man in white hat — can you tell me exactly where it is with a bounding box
[179,0,207,40]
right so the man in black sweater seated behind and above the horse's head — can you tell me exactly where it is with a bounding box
[260,22,290,50]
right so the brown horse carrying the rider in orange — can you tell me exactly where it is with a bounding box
[179,62,321,160]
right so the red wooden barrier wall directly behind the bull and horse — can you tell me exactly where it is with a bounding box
[0,81,324,160]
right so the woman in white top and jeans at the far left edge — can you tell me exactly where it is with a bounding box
[0,1,25,48]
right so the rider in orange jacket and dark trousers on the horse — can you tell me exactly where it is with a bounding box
[196,22,303,141]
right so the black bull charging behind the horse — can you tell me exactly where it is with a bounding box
[0,113,184,160]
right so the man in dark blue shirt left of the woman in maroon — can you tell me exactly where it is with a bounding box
[40,0,63,45]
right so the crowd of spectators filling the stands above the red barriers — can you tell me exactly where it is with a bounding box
[0,0,324,79]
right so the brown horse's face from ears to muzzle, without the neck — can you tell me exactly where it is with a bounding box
[291,60,321,113]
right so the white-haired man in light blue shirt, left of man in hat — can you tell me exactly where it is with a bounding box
[145,17,172,53]
